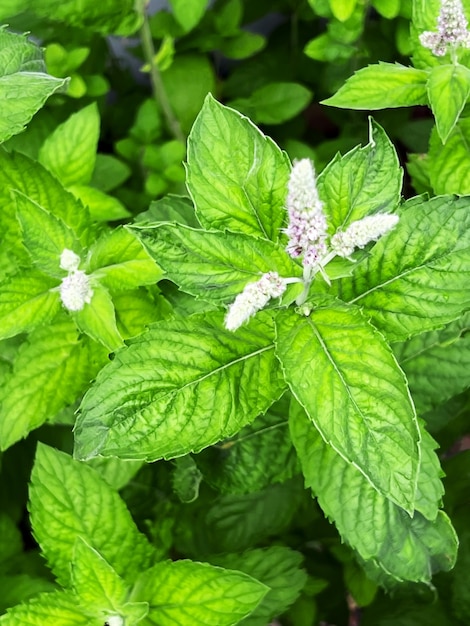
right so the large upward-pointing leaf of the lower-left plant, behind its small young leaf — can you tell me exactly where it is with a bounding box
[29,444,153,584]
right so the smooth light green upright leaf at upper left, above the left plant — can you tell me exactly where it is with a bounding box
[39,102,100,187]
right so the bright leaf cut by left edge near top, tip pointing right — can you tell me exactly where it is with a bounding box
[0,28,67,142]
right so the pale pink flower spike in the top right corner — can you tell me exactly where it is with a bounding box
[419,0,470,57]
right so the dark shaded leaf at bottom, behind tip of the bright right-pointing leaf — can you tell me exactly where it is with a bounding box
[211,546,307,626]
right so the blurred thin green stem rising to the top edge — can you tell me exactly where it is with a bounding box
[139,0,186,143]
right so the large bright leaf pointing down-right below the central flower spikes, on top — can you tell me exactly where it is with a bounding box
[276,303,420,514]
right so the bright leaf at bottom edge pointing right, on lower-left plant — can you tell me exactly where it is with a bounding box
[131,561,269,626]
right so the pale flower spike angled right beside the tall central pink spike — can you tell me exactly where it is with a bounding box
[330,213,399,257]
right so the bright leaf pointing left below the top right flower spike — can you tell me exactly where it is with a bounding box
[322,63,428,111]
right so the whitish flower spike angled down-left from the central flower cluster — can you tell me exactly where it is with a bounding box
[225,272,287,331]
